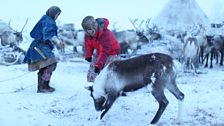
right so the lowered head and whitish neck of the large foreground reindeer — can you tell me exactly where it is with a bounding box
[86,67,120,119]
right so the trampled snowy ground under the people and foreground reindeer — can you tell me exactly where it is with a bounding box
[0,60,224,126]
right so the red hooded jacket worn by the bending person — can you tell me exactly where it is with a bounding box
[85,18,120,69]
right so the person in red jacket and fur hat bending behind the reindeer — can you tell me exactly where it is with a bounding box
[82,16,120,82]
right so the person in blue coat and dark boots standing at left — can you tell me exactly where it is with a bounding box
[24,6,63,93]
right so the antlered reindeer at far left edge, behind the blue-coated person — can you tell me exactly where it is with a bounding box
[0,19,28,46]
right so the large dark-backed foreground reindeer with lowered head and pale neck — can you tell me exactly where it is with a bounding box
[87,53,184,124]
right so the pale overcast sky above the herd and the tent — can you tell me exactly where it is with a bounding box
[0,0,224,30]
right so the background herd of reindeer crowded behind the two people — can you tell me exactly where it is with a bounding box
[0,19,224,73]
